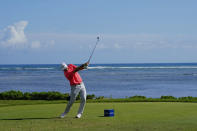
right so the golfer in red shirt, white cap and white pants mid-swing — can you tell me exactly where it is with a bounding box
[60,62,89,118]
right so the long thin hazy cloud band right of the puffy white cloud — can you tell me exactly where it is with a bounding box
[24,33,197,53]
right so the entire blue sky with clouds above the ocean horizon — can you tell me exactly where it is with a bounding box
[0,0,197,64]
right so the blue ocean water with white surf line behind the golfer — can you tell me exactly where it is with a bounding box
[0,63,197,98]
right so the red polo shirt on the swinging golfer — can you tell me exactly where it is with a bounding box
[64,64,82,85]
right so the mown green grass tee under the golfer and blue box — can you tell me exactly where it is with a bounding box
[0,101,197,131]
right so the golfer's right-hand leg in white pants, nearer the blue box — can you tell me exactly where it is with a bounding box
[78,83,86,114]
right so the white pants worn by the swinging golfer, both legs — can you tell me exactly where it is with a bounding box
[64,82,86,114]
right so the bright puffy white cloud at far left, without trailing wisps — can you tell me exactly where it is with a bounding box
[0,21,28,47]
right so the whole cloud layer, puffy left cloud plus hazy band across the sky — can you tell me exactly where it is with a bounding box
[0,21,197,51]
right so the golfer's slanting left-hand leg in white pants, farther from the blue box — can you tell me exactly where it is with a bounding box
[64,86,80,114]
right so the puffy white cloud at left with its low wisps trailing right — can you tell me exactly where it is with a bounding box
[0,21,55,50]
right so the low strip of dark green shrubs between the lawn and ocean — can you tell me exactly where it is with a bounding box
[0,90,197,102]
